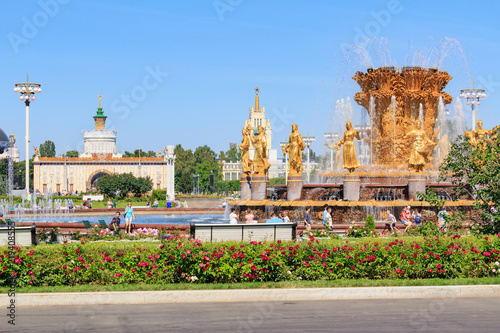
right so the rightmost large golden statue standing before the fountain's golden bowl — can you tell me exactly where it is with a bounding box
[403,119,437,172]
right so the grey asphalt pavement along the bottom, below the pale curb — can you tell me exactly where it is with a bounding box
[6,297,500,333]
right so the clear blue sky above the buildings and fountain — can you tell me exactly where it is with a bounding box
[0,0,500,160]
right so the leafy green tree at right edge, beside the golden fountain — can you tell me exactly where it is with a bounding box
[439,136,500,233]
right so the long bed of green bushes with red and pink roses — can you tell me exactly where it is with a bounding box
[0,235,500,287]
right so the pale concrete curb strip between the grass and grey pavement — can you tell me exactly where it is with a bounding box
[6,285,500,307]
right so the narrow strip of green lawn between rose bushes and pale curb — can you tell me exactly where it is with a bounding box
[0,278,500,293]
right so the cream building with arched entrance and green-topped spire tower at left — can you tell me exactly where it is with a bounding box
[33,96,175,200]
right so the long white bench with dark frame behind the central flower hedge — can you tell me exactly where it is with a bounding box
[190,222,297,242]
